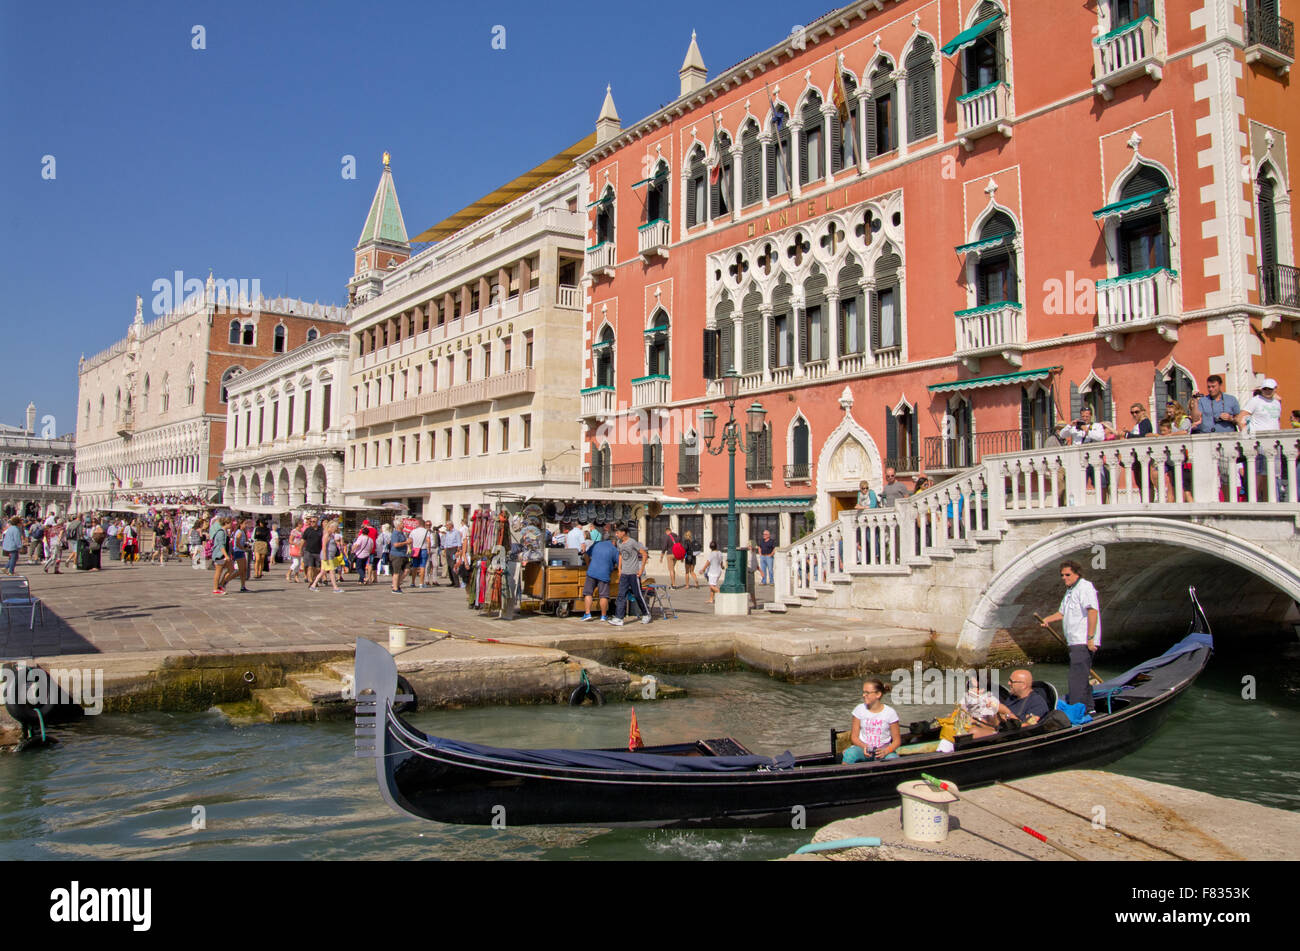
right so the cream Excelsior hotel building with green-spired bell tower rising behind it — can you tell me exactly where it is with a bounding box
[345,149,594,521]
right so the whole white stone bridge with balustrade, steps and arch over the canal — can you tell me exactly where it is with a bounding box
[768,430,1300,663]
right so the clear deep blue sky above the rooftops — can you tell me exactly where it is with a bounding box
[0,0,800,433]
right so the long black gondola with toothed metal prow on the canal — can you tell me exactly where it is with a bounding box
[356,591,1214,828]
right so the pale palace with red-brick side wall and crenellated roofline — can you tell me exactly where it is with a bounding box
[73,274,347,511]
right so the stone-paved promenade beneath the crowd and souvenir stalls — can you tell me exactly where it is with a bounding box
[0,550,795,659]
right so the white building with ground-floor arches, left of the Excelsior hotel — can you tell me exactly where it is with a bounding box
[222,333,348,514]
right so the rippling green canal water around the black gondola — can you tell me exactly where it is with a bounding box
[0,647,1300,860]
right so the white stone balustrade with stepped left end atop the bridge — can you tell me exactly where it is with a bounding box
[775,430,1300,602]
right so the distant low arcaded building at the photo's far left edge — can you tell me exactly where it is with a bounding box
[0,403,75,518]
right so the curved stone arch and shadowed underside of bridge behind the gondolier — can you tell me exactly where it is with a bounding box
[957,516,1300,663]
